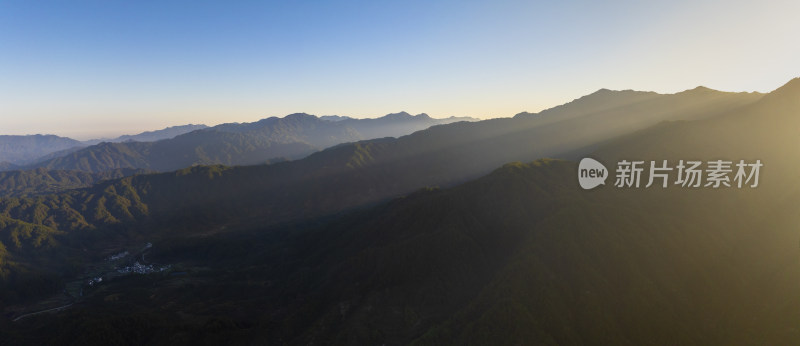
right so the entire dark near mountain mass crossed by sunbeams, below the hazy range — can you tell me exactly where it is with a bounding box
[0,79,800,345]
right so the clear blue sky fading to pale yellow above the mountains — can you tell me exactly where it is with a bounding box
[0,0,800,139]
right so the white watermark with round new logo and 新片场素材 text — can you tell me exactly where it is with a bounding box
[578,158,764,190]
